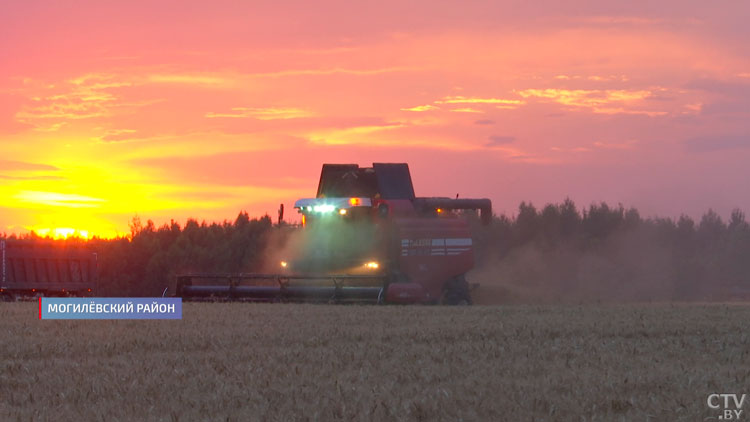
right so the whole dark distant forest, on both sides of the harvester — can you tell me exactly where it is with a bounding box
[2,200,750,303]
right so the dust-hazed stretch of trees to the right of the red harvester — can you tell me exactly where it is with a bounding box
[473,199,750,302]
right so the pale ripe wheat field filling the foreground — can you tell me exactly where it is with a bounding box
[0,303,750,421]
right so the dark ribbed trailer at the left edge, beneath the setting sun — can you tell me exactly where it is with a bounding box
[0,239,97,300]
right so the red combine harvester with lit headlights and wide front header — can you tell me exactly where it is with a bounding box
[177,163,492,305]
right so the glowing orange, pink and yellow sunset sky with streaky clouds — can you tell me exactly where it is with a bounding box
[0,0,750,236]
